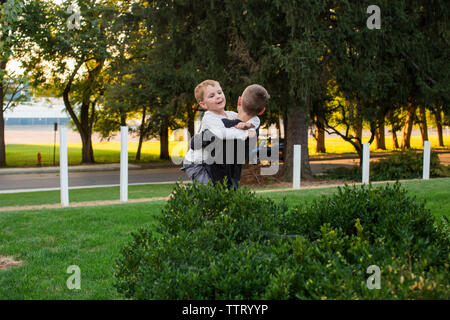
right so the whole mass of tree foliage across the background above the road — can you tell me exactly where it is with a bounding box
[11,0,450,170]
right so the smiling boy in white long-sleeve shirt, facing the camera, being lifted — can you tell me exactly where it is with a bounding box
[182,80,264,185]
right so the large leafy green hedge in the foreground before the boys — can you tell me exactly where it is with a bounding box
[115,184,450,299]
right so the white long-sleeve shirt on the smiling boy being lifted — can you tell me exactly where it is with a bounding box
[184,111,260,164]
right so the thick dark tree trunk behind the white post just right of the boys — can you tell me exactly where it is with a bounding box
[281,107,312,181]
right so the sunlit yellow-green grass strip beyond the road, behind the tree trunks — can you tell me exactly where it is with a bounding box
[6,136,450,167]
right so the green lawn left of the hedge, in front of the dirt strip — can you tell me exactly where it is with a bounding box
[0,202,162,299]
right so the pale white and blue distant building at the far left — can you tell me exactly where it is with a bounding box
[4,97,70,126]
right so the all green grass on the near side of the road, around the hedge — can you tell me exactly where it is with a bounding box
[0,178,450,299]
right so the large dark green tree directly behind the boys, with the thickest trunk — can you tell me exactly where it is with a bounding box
[133,0,323,178]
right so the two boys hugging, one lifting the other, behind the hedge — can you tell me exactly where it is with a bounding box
[182,80,270,188]
